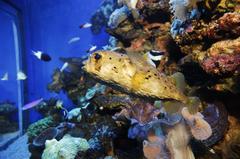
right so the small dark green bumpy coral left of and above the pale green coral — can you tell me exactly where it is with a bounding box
[27,116,57,141]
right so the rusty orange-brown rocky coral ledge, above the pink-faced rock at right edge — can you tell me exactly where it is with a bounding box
[174,12,240,47]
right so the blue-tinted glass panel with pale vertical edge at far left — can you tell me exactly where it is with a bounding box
[0,2,22,149]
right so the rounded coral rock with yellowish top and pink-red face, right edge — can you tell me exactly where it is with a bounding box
[194,38,240,75]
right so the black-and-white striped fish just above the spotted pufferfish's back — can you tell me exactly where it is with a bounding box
[146,50,164,68]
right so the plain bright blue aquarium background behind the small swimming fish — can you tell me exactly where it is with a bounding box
[0,0,108,124]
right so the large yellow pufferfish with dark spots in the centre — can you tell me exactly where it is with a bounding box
[83,51,186,102]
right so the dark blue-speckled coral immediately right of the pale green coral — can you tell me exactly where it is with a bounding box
[74,112,120,158]
